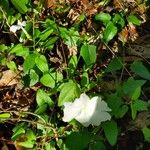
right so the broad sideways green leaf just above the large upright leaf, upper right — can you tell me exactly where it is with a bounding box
[95,12,111,25]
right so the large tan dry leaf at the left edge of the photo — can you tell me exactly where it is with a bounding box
[0,70,18,87]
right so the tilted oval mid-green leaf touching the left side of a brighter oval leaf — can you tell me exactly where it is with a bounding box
[23,54,37,74]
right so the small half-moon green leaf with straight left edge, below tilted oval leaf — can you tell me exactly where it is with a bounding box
[30,69,39,86]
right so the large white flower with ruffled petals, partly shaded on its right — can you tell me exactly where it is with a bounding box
[63,93,111,127]
